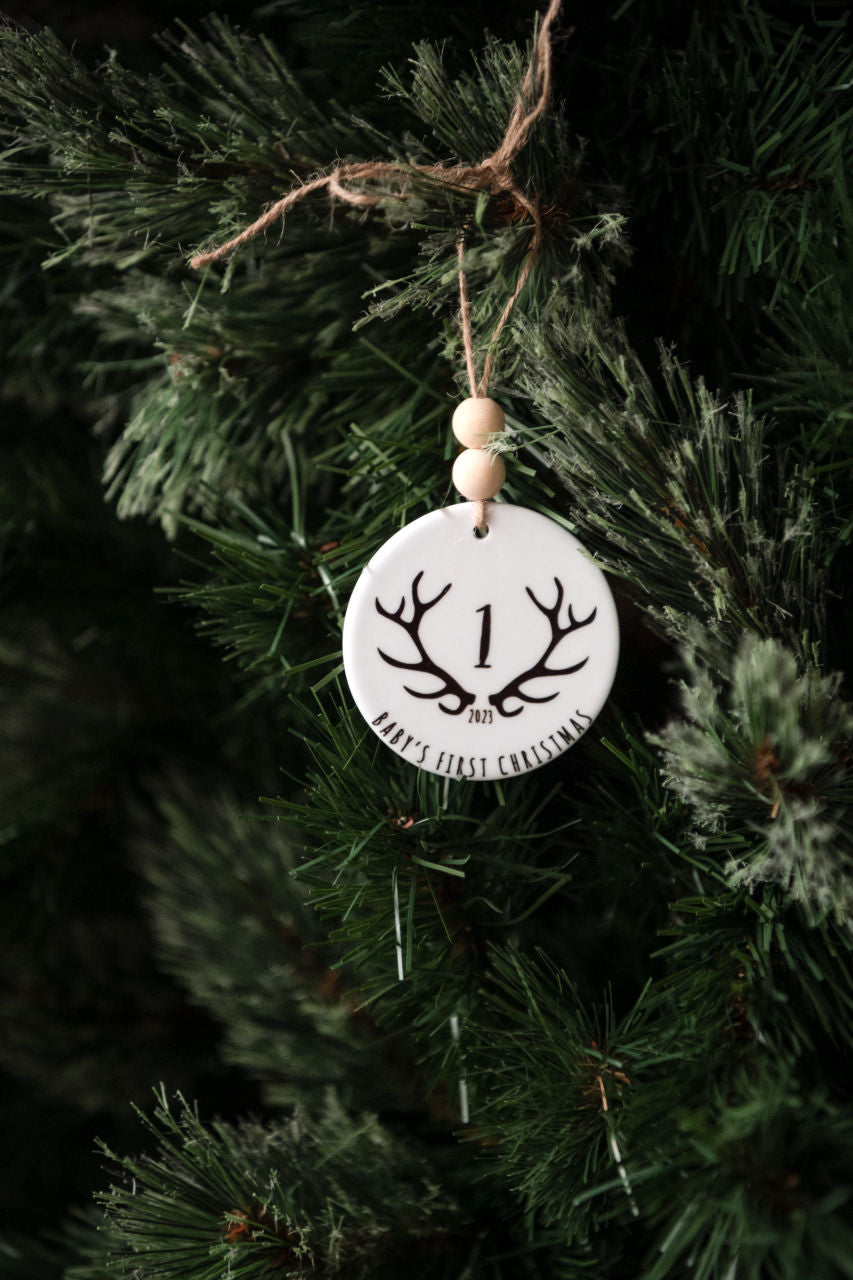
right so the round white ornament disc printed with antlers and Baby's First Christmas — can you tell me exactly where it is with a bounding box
[343,503,619,781]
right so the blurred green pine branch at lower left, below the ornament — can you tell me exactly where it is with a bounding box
[137,782,416,1110]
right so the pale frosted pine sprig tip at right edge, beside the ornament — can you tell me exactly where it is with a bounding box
[650,636,853,928]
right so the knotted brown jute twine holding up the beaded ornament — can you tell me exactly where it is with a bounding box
[190,0,562,531]
